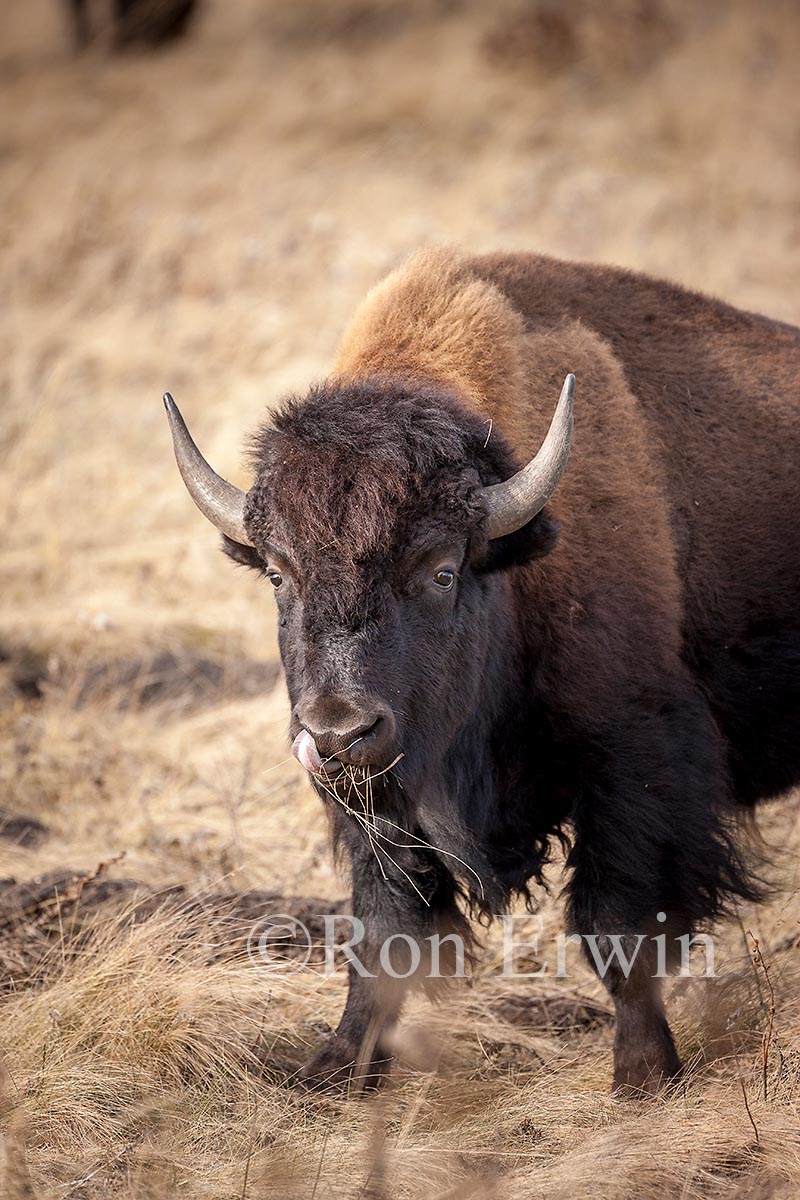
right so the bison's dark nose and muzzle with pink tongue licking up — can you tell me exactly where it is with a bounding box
[295,695,395,769]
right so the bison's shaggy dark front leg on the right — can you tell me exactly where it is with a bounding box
[569,679,758,1091]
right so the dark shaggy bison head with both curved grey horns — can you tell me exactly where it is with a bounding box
[164,376,575,790]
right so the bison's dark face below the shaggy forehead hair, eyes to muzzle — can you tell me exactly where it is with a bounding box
[250,522,503,781]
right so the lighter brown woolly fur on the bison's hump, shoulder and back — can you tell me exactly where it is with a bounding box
[335,250,800,777]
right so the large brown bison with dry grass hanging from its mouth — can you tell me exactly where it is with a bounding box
[166,250,800,1091]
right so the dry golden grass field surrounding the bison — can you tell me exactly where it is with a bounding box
[0,0,800,1200]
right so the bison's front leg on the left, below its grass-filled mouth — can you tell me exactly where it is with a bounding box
[299,826,468,1091]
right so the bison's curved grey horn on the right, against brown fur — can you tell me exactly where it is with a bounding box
[483,374,575,538]
